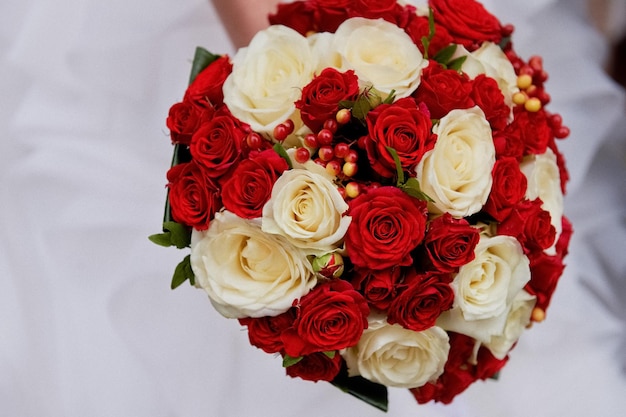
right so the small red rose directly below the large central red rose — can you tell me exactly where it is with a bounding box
[352,268,402,311]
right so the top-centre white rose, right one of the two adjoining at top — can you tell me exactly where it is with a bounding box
[334,17,428,99]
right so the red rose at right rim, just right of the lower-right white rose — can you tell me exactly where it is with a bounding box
[526,252,565,311]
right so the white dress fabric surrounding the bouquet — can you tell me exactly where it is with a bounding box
[0,0,626,417]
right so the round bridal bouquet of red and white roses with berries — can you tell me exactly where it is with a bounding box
[151,0,572,410]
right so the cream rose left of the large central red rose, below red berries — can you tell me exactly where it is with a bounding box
[262,169,350,254]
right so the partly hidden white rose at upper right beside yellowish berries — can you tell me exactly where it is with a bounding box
[454,42,519,106]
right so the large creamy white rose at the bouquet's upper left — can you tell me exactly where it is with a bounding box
[223,25,317,134]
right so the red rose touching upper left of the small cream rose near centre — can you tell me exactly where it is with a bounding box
[221,149,289,219]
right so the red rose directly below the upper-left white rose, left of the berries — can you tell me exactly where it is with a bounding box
[189,111,246,178]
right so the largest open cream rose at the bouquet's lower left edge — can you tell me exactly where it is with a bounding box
[191,211,316,318]
